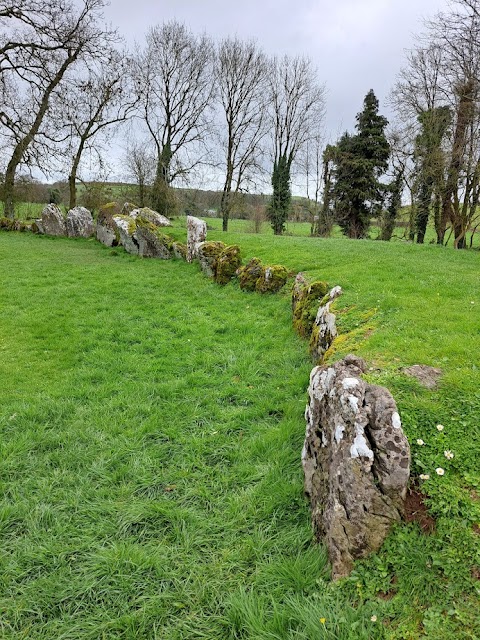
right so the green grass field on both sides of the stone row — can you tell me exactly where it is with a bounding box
[0,228,480,640]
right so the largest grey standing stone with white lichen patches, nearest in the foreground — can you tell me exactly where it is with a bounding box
[302,355,410,578]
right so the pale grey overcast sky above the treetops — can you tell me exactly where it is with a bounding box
[105,0,448,141]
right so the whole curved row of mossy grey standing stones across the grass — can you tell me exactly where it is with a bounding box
[15,203,410,578]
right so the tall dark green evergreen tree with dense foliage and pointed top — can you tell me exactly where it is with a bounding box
[333,90,390,238]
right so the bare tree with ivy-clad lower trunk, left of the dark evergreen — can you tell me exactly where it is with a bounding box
[269,56,325,235]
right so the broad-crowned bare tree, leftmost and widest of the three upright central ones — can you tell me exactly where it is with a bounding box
[134,21,214,214]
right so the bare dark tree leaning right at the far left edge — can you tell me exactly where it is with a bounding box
[0,0,116,217]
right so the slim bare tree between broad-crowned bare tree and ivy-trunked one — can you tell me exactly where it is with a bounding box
[216,38,268,231]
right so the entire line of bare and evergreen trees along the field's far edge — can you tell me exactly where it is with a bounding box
[0,0,480,248]
